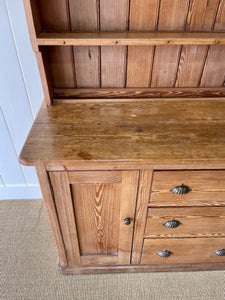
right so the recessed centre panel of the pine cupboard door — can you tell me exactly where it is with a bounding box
[71,180,120,255]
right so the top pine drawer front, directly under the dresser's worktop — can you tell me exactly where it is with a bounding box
[149,170,225,207]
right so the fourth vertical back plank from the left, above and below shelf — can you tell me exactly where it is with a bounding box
[127,0,158,87]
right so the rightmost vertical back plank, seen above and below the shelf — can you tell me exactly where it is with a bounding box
[200,0,225,87]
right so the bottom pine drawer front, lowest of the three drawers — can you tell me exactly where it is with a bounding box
[141,238,225,266]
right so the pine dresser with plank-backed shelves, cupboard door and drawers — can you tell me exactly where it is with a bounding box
[20,0,225,274]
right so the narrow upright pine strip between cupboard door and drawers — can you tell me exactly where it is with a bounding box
[131,170,153,264]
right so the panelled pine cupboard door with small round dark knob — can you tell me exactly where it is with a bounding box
[49,171,139,267]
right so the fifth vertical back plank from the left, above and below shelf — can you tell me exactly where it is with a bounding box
[151,0,189,87]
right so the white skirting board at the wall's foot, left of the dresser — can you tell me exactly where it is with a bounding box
[0,185,42,200]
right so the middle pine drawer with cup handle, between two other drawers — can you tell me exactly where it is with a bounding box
[145,207,225,238]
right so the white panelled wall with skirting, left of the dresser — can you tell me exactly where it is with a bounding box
[0,0,44,199]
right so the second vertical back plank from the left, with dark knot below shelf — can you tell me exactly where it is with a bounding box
[69,0,100,88]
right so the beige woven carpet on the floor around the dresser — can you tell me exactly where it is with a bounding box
[0,200,225,300]
